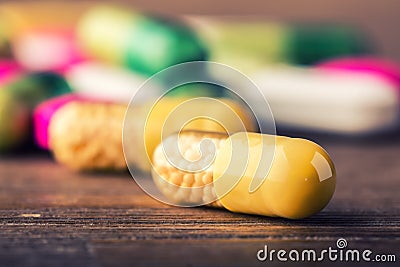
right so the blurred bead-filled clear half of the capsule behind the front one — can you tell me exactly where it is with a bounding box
[48,101,126,171]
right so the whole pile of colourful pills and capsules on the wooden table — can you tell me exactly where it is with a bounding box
[0,2,400,219]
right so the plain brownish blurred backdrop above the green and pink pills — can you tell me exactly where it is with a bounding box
[121,0,400,60]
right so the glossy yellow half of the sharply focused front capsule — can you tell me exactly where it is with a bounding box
[213,132,336,219]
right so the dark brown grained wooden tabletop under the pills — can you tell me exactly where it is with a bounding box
[0,136,400,266]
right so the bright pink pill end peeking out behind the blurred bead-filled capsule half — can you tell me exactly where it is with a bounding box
[33,94,87,150]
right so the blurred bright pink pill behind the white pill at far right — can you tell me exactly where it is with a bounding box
[316,57,400,88]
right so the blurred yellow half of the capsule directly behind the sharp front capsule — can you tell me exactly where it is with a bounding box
[124,97,258,172]
